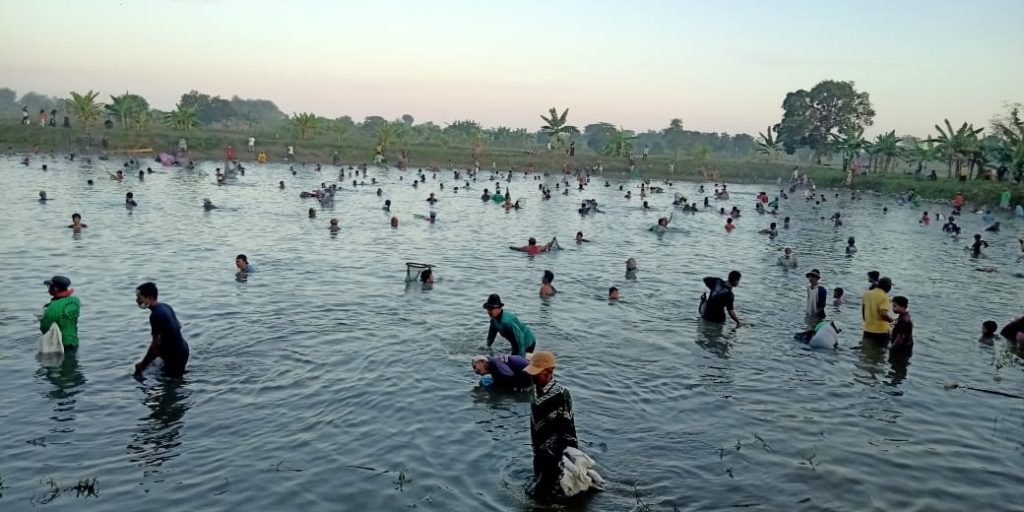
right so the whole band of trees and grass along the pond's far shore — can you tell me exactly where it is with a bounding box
[0,81,1024,208]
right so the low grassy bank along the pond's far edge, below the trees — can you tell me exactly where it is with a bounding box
[0,122,1024,206]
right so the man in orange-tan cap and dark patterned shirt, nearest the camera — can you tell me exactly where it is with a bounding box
[523,351,579,499]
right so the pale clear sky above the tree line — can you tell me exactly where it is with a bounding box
[0,0,1024,135]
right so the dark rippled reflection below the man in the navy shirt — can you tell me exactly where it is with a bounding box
[128,379,191,467]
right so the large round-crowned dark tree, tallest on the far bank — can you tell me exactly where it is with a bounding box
[778,80,874,163]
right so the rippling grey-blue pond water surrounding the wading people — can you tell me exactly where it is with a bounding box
[0,159,1024,511]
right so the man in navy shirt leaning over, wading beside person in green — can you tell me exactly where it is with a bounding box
[135,283,188,378]
